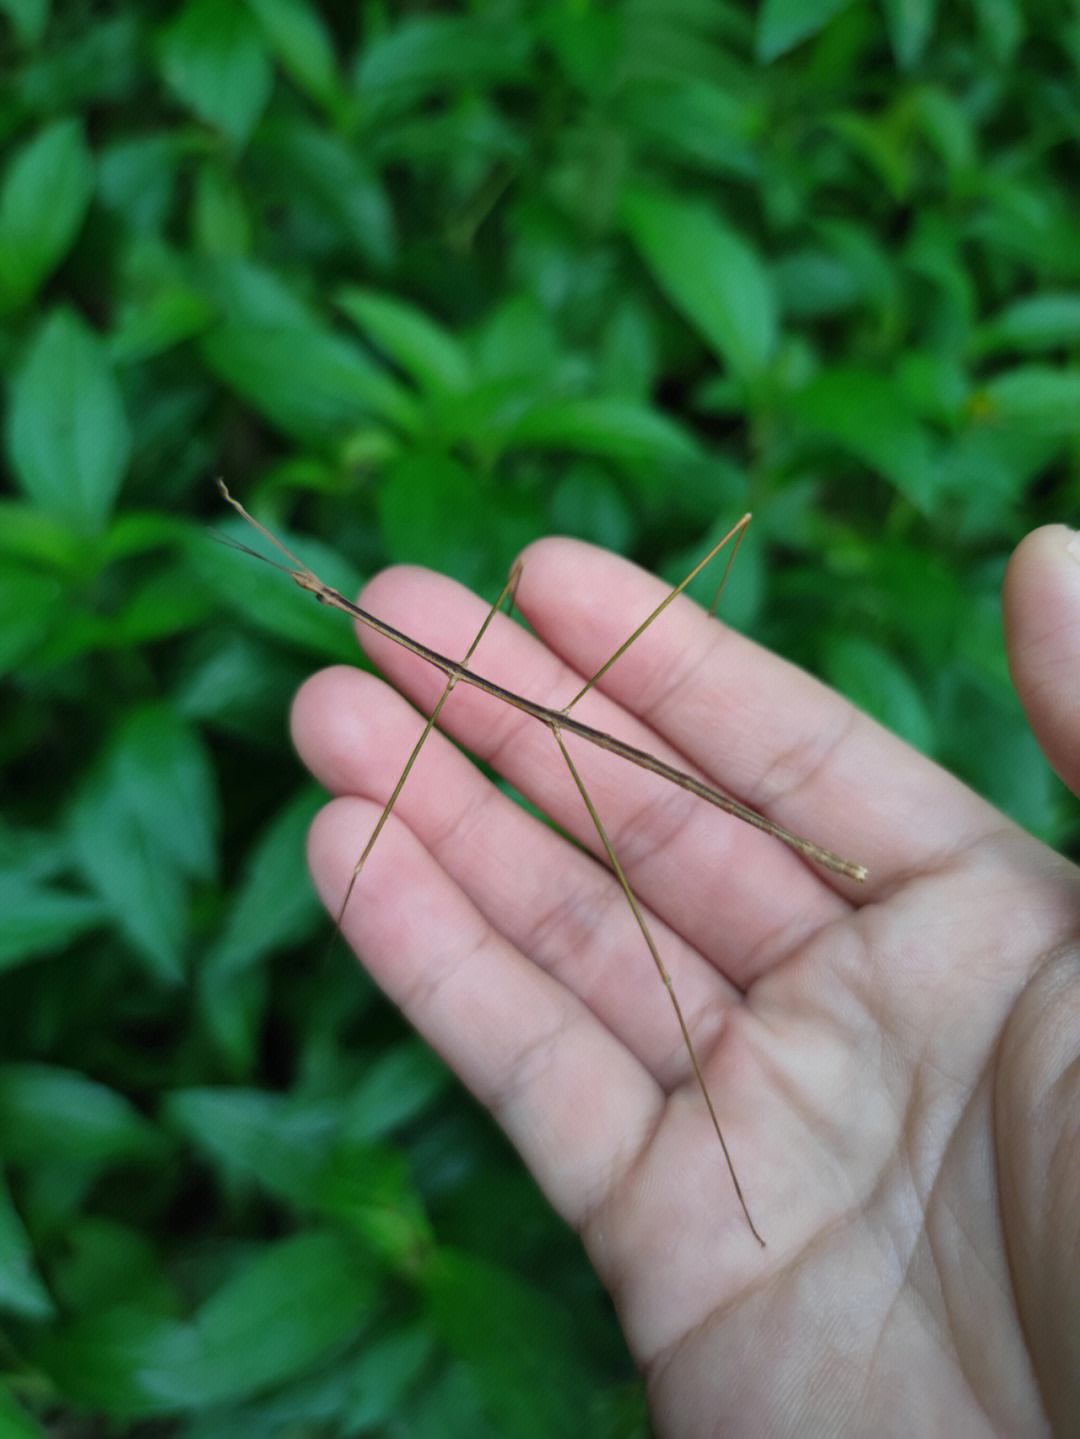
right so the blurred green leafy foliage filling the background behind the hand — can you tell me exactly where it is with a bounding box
[0,0,1080,1439]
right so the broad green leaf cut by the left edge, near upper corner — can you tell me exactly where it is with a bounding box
[0,119,93,314]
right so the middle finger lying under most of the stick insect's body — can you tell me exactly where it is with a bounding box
[337,555,846,987]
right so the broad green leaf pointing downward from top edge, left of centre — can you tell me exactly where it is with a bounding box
[158,0,273,147]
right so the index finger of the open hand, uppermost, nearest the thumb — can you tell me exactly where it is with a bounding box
[518,540,1002,901]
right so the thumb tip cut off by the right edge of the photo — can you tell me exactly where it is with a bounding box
[1002,525,1080,794]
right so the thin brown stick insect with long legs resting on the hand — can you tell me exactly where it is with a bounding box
[217,479,867,1248]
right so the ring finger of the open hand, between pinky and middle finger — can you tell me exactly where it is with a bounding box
[292,666,736,1088]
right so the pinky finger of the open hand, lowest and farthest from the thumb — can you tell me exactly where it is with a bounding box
[308,800,664,1225]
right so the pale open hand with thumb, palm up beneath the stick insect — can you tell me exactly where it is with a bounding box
[293,527,1080,1436]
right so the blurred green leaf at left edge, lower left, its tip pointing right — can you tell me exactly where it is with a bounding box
[0,1063,167,1168]
